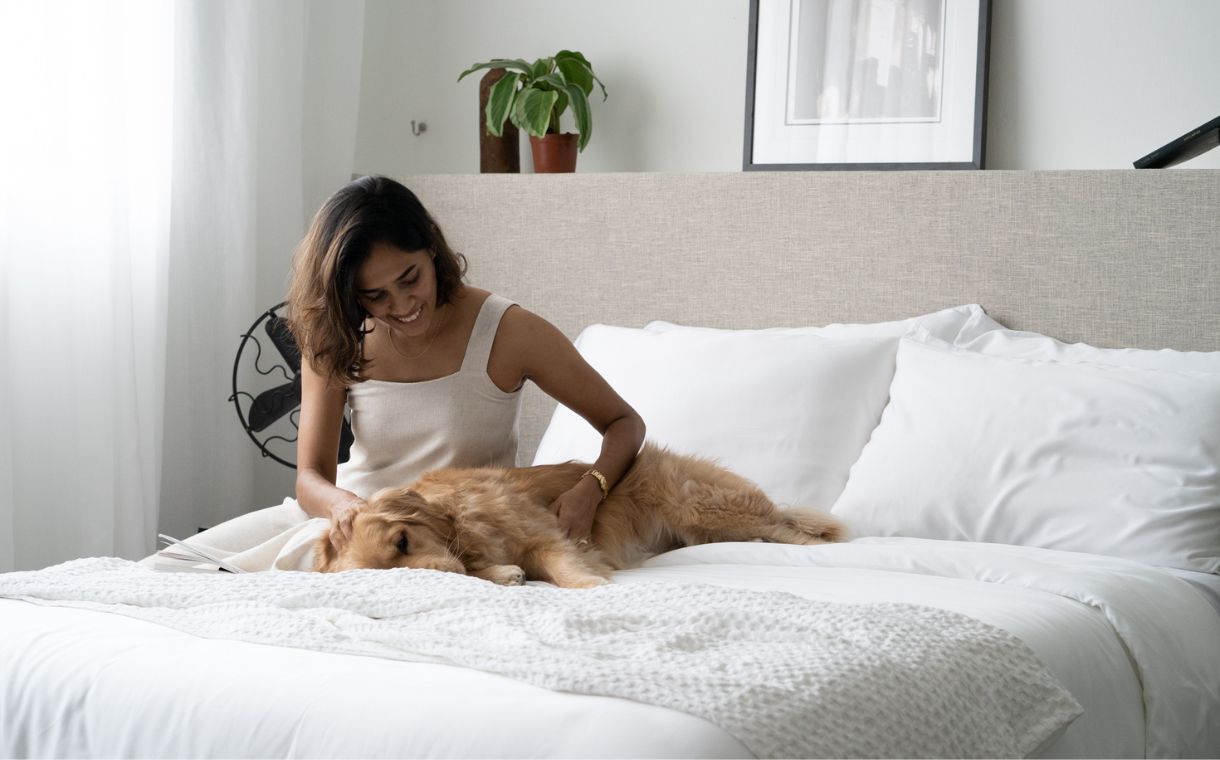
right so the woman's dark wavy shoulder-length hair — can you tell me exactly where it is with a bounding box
[288,177,466,385]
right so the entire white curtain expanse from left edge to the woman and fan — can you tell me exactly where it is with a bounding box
[0,0,364,571]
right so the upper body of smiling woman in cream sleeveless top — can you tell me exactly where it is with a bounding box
[288,177,644,544]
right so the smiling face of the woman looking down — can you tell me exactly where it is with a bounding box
[356,243,437,337]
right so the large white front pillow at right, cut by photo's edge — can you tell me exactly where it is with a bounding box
[833,331,1220,572]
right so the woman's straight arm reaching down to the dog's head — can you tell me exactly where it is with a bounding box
[296,359,365,542]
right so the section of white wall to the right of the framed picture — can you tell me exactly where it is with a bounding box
[987,0,1220,168]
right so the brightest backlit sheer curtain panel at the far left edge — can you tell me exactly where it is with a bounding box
[0,0,173,570]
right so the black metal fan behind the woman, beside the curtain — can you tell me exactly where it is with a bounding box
[229,304,354,467]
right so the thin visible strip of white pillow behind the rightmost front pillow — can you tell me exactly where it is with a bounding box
[951,322,1220,372]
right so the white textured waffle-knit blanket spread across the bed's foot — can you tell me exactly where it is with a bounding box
[0,557,1081,758]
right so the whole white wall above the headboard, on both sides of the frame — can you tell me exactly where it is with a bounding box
[356,0,1220,174]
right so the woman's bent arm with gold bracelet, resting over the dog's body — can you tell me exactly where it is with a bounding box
[488,307,644,540]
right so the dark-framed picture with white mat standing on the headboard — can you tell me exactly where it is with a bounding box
[743,0,991,171]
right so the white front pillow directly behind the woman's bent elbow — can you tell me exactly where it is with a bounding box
[534,324,895,509]
